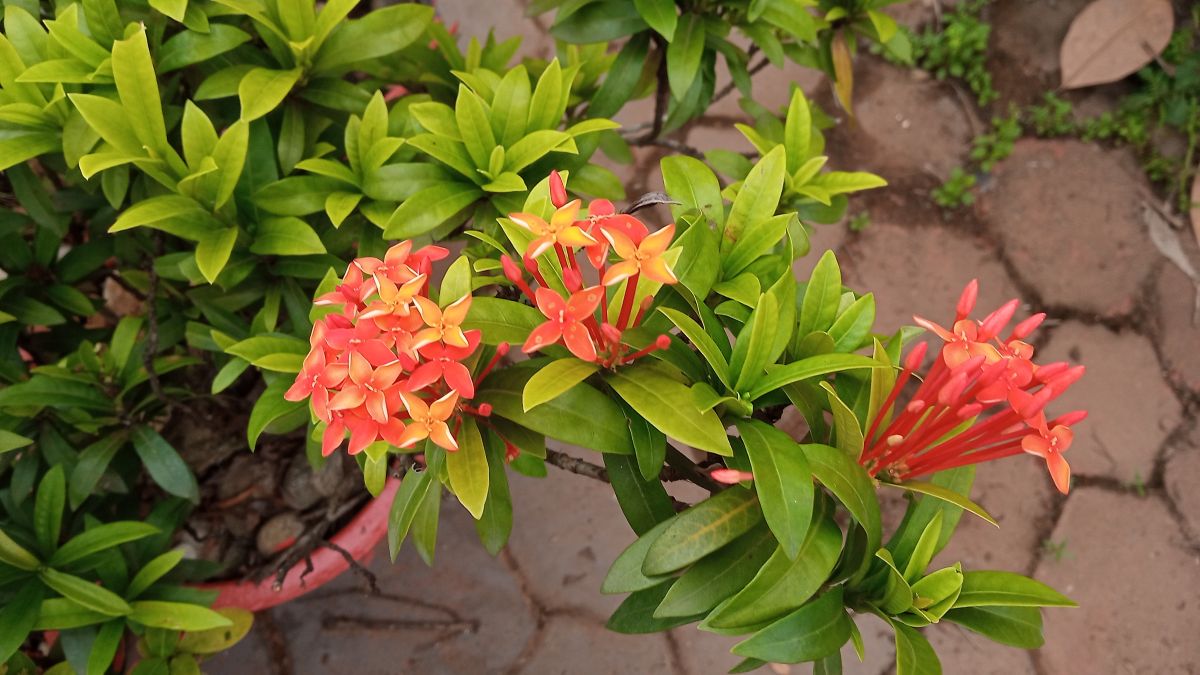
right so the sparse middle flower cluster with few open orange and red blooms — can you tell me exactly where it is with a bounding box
[500,172,678,368]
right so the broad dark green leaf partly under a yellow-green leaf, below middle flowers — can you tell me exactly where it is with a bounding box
[472,362,634,455]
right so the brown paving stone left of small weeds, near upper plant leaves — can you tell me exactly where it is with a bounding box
[826,56,972,179]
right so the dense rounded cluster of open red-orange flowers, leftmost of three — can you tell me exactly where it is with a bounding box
[283,241,506,455]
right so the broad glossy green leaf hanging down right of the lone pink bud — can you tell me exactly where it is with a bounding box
[738,419,814,558]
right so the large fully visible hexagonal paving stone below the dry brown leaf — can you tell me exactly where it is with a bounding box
[979,141,1158,317]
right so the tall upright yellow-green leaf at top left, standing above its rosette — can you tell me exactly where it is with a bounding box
[111,28,166,156]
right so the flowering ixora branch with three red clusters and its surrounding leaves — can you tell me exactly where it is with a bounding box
[288,157,1085,673]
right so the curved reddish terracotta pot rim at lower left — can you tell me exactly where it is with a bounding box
[196,477,400,611]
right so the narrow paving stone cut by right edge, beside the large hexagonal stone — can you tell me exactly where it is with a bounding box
[1154,232,1200,392]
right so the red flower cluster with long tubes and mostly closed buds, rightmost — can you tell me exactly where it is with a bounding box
[859,280,1087,494]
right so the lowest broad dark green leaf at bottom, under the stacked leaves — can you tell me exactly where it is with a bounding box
[731,586,851,663]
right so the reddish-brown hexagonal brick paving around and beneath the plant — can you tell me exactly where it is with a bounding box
[216,0,1200,675]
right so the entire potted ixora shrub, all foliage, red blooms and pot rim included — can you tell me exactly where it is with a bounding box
[0,0,1084,675]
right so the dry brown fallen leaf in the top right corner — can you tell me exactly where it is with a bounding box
[1058,0,1175,89]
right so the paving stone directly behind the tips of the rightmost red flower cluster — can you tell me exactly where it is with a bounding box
[1038,322,1182,483]
